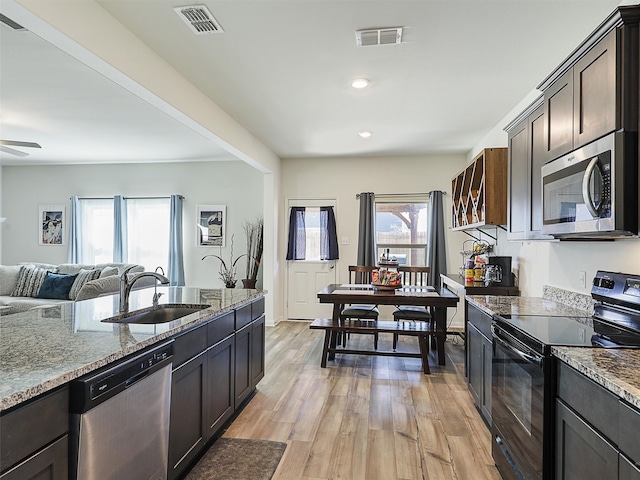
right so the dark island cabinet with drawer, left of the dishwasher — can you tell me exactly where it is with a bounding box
[0,386,69,480]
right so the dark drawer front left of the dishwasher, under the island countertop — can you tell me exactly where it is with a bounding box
[0,387,69,471]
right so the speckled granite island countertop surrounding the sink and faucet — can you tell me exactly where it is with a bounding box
[0,287,265,411]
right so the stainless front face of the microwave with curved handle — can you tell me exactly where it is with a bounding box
[542,135,615,235]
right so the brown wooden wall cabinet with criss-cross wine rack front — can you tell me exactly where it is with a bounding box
[451,148,507,230]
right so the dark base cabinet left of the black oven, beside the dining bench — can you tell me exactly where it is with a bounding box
[465,301,493,427]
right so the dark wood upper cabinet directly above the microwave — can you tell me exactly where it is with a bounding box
[538,6,640,161]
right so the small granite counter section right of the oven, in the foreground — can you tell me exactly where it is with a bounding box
[551,347,640,408]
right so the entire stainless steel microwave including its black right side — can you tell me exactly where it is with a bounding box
[542,132,638,239]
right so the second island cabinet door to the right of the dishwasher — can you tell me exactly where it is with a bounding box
[206,336,235,437]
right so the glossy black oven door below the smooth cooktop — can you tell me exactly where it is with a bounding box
[491,323,545,479]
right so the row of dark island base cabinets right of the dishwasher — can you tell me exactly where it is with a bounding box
[167,300,265,480]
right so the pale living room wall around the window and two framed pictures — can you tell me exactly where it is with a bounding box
[2,162,264,288]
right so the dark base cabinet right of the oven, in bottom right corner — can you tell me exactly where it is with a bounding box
[555,362,640,480]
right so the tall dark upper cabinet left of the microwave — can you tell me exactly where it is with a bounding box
[505,97,553,240]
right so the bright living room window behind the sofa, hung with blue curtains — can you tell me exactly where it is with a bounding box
[80,198,171,272]
